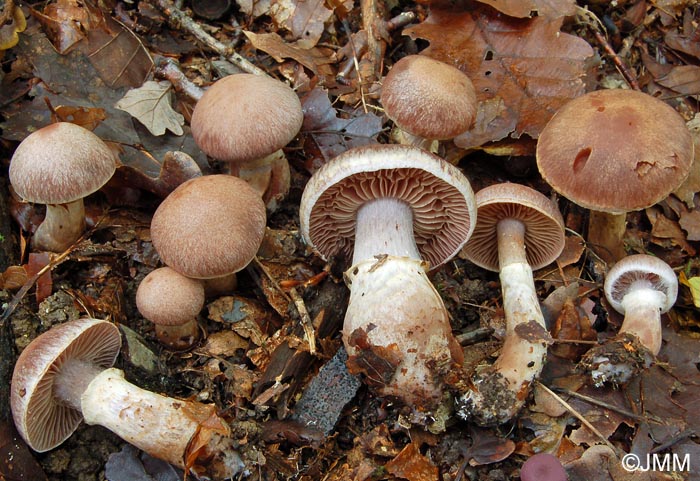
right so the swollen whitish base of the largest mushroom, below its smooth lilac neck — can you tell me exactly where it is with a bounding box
[343,255,463,411]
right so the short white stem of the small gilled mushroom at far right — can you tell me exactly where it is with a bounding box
[619,280,666,356]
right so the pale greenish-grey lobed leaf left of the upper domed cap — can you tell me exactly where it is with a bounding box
[115,80,185,135]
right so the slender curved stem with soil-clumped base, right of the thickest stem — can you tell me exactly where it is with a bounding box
[458,219,547,425]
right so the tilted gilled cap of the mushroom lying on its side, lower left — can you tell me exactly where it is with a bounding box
[10,319,121,452]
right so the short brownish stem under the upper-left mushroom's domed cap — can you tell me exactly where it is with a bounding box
[33,199,85,252]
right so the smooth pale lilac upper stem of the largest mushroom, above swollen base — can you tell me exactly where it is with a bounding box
[352,198,420,265]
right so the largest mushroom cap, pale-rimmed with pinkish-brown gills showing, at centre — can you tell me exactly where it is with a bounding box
[299,145,476,268]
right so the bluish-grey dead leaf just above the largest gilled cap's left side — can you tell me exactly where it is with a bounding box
[301,88,382,172]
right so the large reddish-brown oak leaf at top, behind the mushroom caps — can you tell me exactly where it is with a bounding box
[404,4,593,148]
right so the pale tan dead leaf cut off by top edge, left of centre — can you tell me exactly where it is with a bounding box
[270,0,333,49]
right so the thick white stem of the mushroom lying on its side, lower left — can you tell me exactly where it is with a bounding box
[54,360,242,479]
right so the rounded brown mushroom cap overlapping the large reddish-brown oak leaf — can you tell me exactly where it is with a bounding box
[380,55,477,140]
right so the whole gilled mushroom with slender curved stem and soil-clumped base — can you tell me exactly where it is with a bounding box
[457,184,564,426]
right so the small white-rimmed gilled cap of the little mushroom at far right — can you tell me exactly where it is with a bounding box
[604,254,678,314]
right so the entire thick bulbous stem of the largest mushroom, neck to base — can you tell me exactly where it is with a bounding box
[343,199,462,410]
